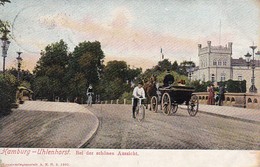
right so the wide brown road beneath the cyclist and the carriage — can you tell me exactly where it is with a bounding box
[86,104,260,150]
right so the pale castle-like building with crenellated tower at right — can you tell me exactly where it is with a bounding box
[191,41,260,90]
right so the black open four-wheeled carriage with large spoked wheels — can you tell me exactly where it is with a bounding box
[150,86,199,116]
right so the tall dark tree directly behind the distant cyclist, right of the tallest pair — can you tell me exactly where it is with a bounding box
[65,41,105,98]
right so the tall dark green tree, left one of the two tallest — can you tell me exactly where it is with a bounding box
[33,40,69,100]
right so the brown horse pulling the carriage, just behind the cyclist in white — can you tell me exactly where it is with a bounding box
[143,75,157,110]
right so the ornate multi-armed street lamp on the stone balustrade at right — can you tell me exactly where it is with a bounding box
[245,45,257,93]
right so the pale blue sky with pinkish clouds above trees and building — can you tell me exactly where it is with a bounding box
[0,0,260,70]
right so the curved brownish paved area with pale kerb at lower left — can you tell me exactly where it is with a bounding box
[0,101,98,148]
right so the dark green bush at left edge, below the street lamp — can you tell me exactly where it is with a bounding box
[0,74,17,115]
